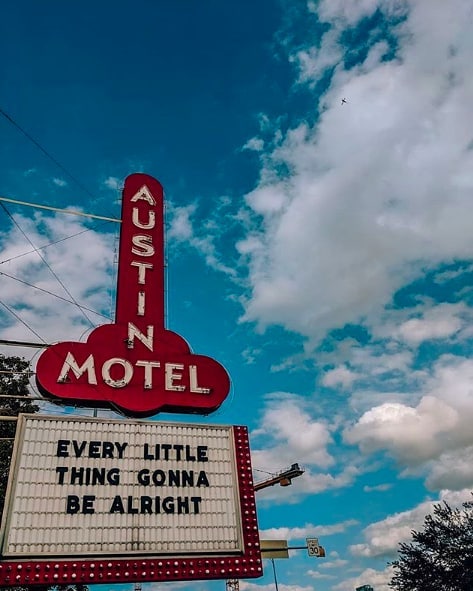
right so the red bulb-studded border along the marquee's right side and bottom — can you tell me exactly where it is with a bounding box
[0,426,263,586]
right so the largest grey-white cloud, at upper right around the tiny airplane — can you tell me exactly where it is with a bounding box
[240,0,473,342]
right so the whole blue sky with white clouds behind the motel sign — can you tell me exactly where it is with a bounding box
[0,0,473,591]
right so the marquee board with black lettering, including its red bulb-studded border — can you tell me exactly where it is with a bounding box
[0,415,262,586]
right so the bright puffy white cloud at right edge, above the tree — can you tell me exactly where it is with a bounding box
[345,355,473,489]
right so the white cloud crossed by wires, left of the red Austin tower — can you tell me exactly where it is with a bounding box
[0,214,116,354]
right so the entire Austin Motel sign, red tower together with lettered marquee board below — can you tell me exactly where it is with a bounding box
[0,174,262,586]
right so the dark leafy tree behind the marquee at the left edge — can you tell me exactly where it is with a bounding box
[0,354,88,591]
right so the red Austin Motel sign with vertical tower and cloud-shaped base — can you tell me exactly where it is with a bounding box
[36,174,230,417]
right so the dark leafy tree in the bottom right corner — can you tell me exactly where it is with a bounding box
[390,501,473,591]
